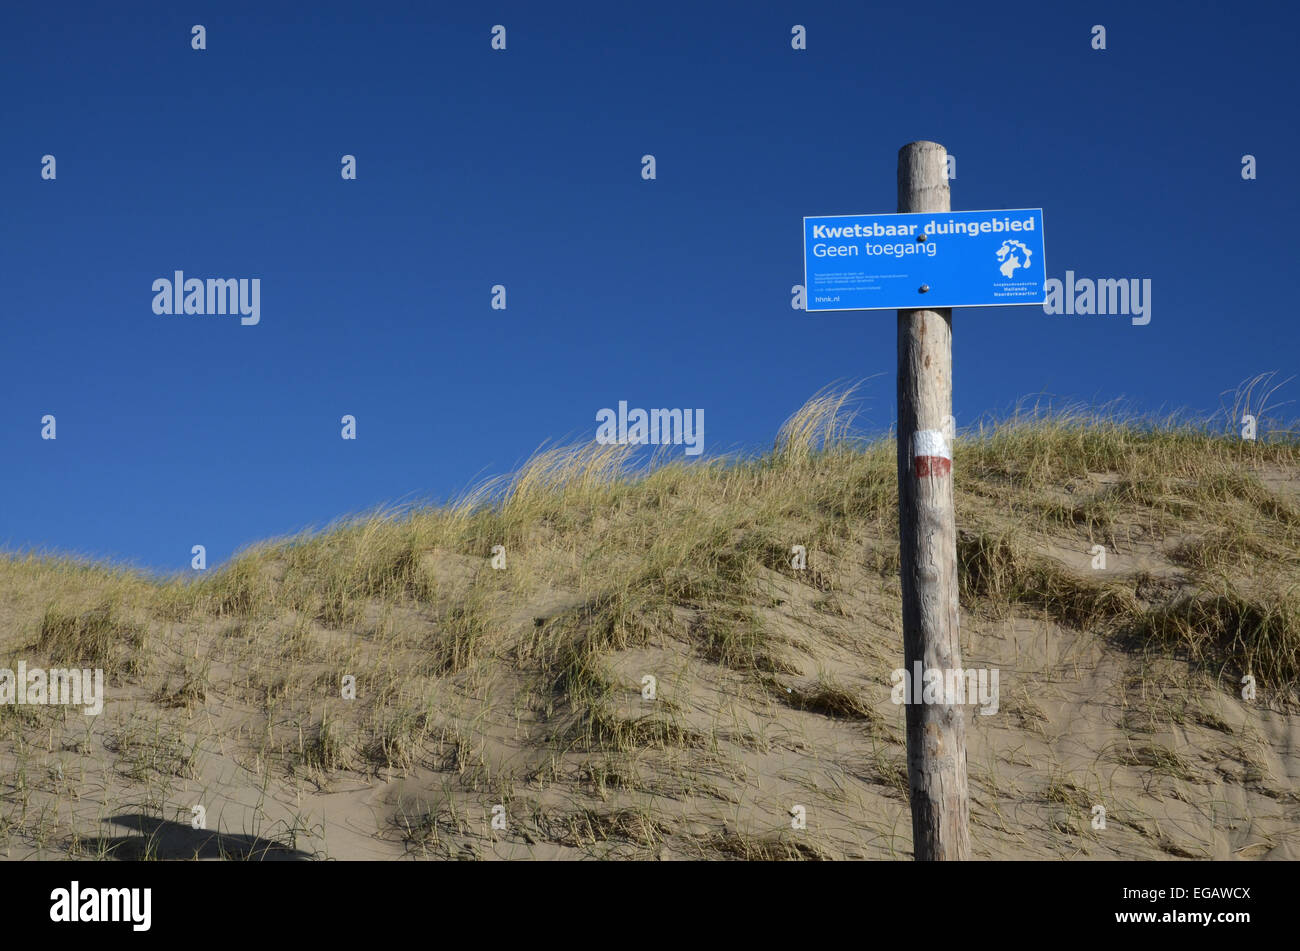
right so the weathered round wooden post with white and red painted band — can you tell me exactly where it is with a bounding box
[898,142,970,861]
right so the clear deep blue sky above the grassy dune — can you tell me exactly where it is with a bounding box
[0,3,1300,570]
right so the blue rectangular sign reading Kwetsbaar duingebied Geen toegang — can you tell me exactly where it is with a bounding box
[803,208,1047,313]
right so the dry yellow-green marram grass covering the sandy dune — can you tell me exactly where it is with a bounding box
[0,381,1300,859]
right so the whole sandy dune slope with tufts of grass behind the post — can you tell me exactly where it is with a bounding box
[0,404,1300,859]
